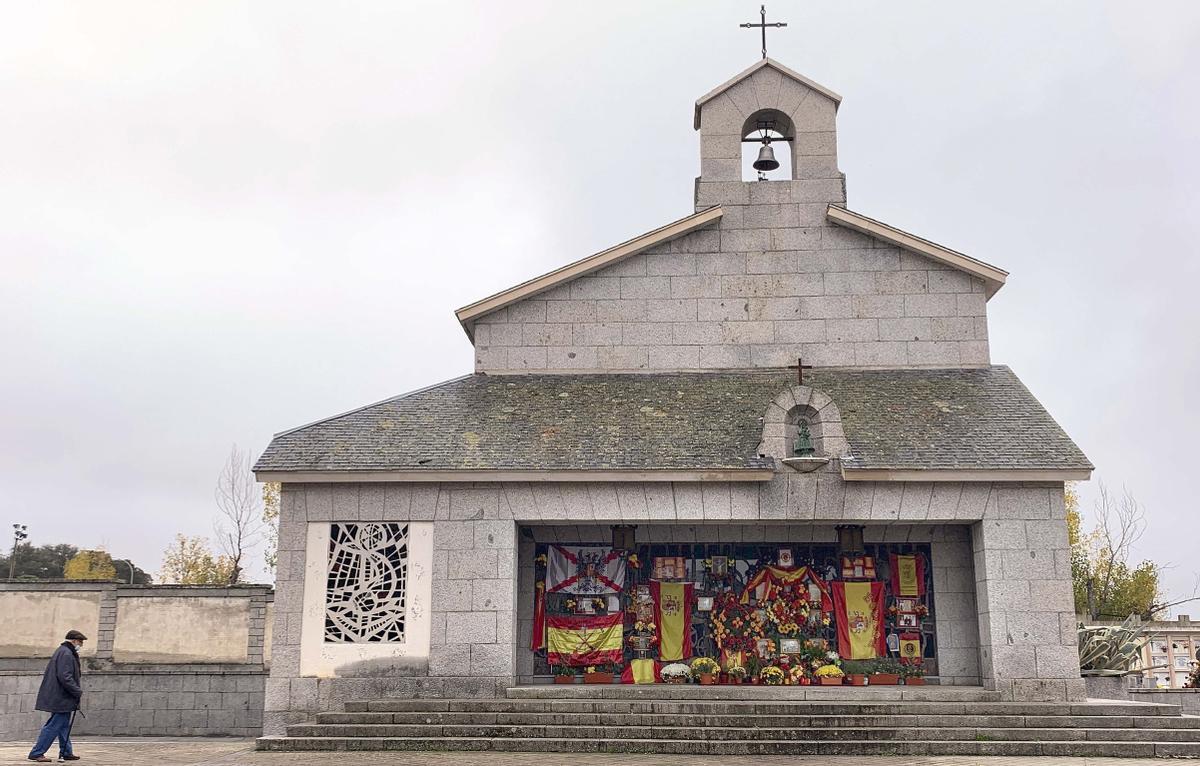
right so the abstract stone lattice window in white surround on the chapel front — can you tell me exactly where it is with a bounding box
[325,523,408,644]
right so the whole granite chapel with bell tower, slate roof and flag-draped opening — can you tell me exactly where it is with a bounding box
[256,58,1092,735]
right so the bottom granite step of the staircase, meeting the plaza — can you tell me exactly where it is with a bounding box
[258,736,1200,758]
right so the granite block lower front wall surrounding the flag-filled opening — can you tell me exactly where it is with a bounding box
[272,477,1081,734]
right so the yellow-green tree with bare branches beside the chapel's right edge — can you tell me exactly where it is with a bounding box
[1066,484,1163,622]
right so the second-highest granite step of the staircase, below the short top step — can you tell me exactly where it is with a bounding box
[344,699,1180,717]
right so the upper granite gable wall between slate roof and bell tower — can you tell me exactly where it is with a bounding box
[475,214,989,373]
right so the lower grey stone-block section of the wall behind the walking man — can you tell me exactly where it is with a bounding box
[0,668,266,741]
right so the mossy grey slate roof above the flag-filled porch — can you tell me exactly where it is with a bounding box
[254,366,1092,472]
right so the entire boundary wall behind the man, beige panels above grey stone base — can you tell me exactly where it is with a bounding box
[0,582,274,741]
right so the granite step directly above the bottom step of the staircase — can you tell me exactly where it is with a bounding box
[287,724,1200,743]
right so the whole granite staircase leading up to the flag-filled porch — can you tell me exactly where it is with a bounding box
[258,686,1200,758]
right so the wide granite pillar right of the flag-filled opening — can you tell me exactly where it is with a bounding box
[971,484,1086,701]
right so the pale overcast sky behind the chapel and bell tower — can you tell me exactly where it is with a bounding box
[0,0,1200,605]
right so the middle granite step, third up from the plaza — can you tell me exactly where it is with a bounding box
[316,711,1200,729]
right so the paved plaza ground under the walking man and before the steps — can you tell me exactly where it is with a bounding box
[0,737,1185,766]
